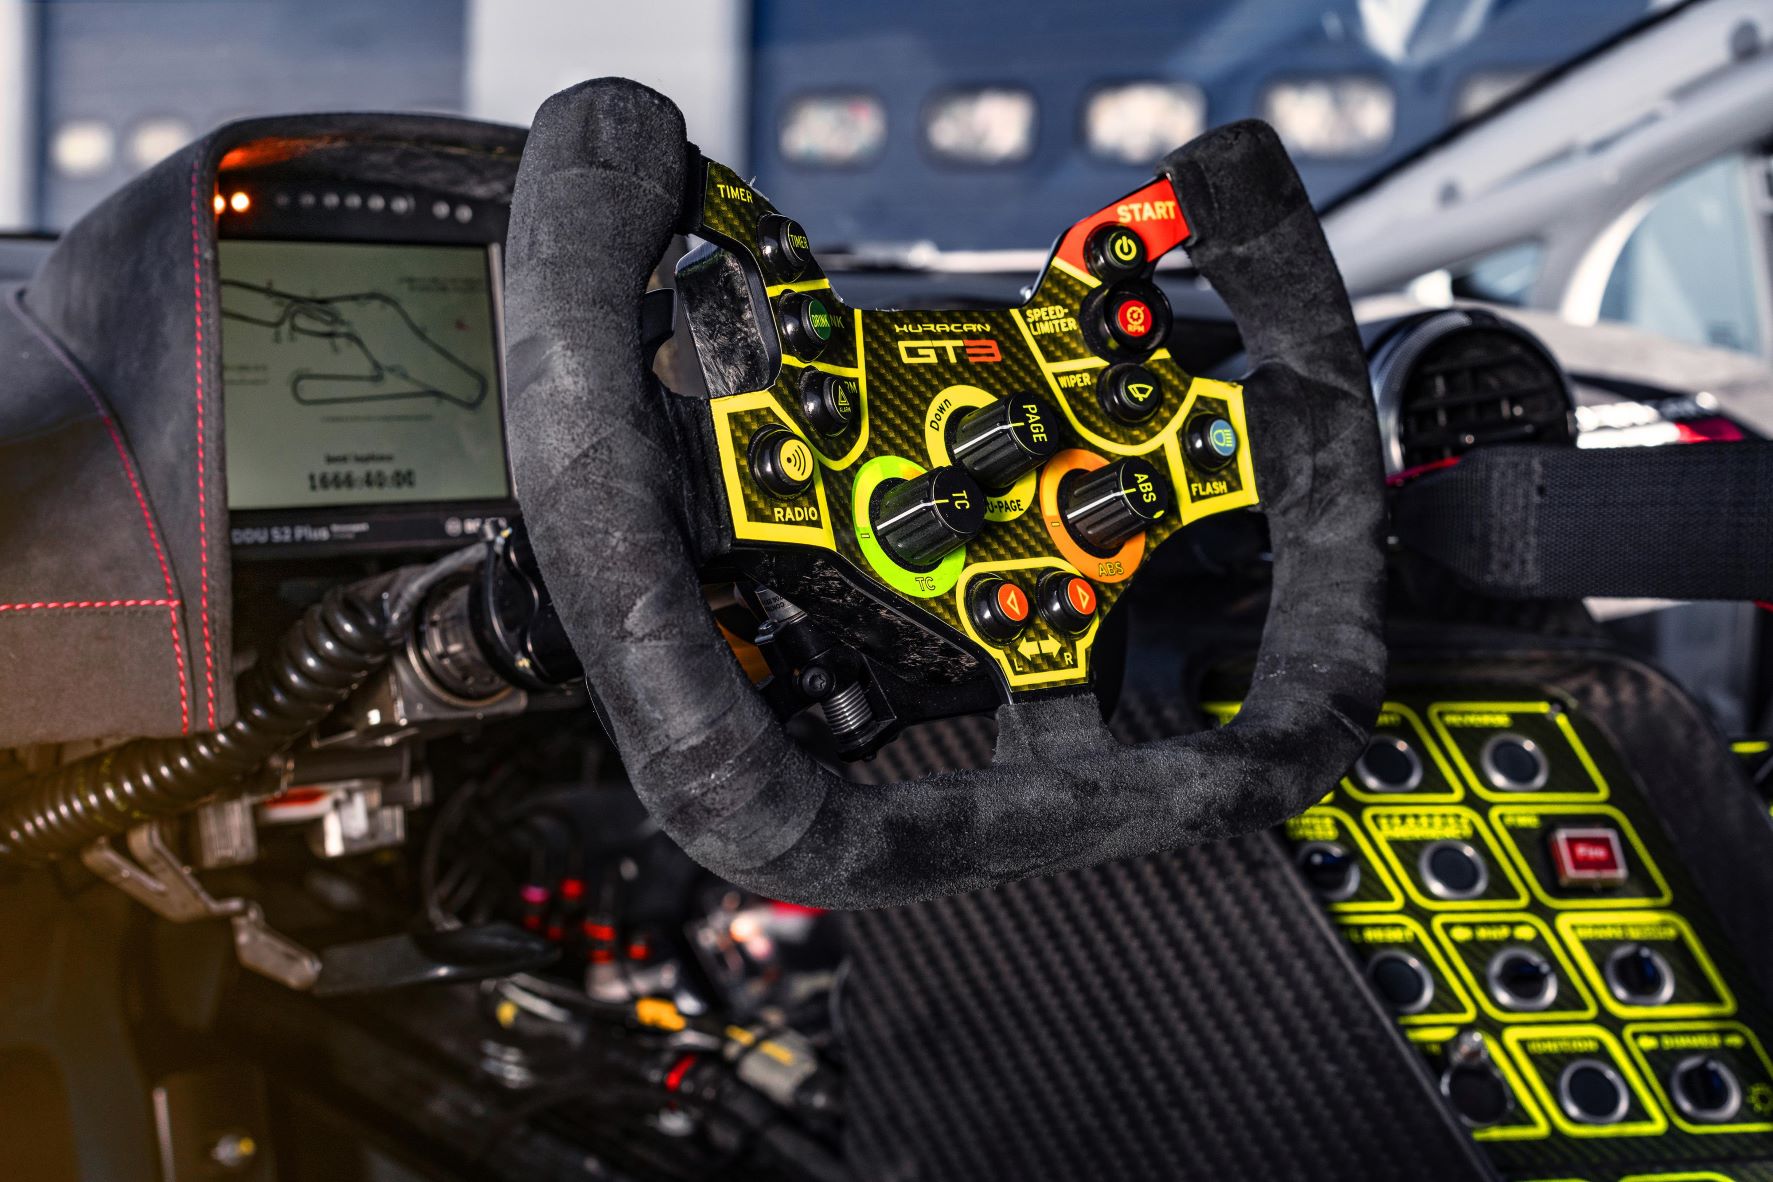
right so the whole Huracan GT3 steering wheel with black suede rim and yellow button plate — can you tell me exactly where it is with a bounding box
[505,80,1385,907]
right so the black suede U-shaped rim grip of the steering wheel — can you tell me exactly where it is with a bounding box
[505,80,1385,907]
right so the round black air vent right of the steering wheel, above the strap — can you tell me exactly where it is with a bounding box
[1372,308,1576,475]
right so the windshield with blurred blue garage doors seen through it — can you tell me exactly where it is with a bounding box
[0,0,1668,250]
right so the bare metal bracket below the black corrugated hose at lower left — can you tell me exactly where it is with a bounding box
[80,820,321,991]
